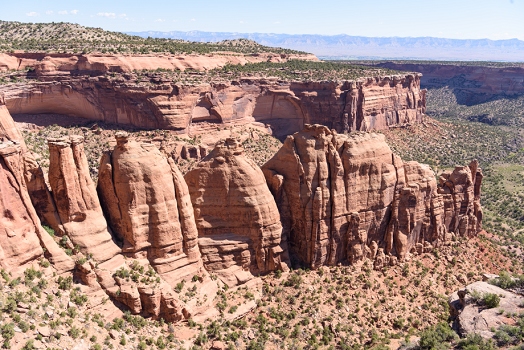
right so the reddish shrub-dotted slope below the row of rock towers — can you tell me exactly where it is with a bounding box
[1,233,522,349]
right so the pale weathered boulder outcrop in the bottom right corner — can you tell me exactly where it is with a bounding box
[448,281,524,339]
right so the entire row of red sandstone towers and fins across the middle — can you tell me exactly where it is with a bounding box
[0,92,482,321]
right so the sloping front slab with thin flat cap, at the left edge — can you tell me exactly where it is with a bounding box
[0,141,74,272]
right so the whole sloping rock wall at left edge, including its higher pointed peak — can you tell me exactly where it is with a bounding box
[0,100,74,272]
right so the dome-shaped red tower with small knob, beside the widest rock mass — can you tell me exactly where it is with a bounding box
[185,138,289,285]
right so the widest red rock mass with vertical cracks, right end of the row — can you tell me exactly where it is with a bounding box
[262,125,482,268]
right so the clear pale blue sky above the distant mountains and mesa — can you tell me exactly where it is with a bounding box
[4,0,524,40]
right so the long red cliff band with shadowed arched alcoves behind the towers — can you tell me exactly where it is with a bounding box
[0,74,426,137]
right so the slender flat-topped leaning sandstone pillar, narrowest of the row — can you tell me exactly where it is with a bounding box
[48,136,120,261]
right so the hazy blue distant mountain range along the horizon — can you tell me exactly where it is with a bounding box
[127,31,524,62]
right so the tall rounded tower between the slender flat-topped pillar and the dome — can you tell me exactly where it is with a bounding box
[98,133,201,283]
